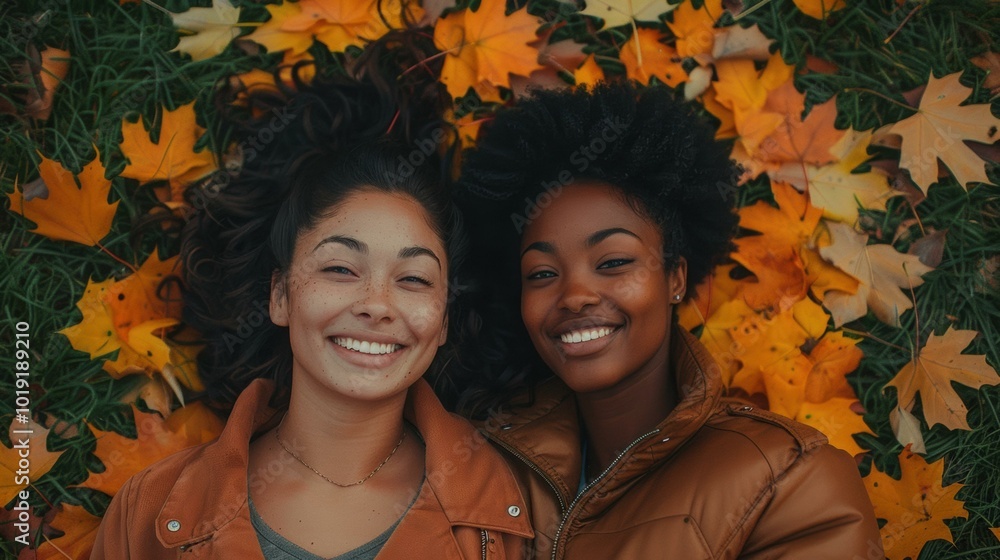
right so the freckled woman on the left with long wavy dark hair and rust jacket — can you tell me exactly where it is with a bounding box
[92,35,532,560]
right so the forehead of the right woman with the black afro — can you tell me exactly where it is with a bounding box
[521,180,660,248]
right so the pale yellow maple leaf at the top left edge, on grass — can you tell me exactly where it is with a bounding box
[170,0,240,60]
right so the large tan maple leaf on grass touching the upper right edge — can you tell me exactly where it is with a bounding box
[879,72,1000,194]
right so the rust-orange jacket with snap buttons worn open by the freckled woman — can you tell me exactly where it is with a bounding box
[91,380,533,560]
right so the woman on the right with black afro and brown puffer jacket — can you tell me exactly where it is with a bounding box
[461,83,882,559]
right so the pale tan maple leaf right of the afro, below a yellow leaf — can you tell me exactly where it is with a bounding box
[820,222,934,327]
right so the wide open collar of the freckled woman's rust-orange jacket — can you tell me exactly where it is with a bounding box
[156,379,533,547]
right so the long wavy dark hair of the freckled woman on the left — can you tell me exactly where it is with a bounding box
[181,31,465,403]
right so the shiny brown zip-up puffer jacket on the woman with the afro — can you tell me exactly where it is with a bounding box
[484,329,884,560]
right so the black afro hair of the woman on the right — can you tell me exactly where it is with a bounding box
[456,81,737,415]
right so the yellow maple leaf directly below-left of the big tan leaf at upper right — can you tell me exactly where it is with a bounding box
[768,129,901,224]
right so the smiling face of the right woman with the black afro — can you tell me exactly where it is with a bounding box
[521,181,687,393]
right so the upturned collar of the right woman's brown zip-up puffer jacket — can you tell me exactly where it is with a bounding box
[487,328,723,510]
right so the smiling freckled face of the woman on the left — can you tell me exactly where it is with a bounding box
[271,190,448,400]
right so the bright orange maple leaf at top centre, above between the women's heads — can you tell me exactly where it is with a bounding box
[434,2,542,98]
